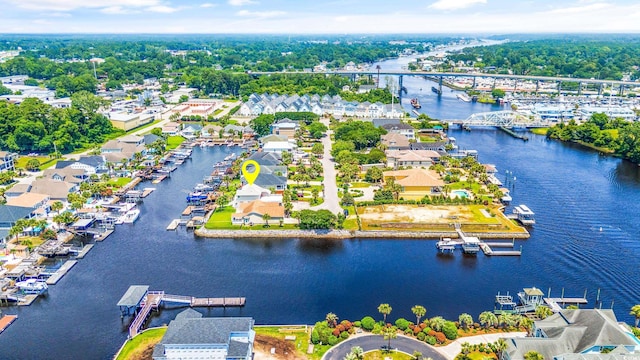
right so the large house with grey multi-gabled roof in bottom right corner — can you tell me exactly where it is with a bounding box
[503,309,640,360]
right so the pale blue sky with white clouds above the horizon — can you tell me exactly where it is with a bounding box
[0,0,640,34]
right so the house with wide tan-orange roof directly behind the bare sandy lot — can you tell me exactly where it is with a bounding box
[383,169,444,198]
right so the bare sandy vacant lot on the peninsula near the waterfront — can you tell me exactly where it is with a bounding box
[358,205,473,224]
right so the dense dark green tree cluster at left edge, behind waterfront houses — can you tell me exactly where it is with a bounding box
[0,91,120,153]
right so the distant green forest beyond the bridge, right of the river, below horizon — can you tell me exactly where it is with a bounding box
[450,37,640,80]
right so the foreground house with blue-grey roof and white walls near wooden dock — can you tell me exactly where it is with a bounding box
[153,309,255,360]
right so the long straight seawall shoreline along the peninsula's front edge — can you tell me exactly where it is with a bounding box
[194,228,531,240]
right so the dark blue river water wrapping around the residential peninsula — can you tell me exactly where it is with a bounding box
[0,55,640,359]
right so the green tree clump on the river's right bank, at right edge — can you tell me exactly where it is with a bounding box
[547,114,640,163]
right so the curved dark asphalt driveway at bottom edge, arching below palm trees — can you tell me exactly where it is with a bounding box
[322,335,447,360]
